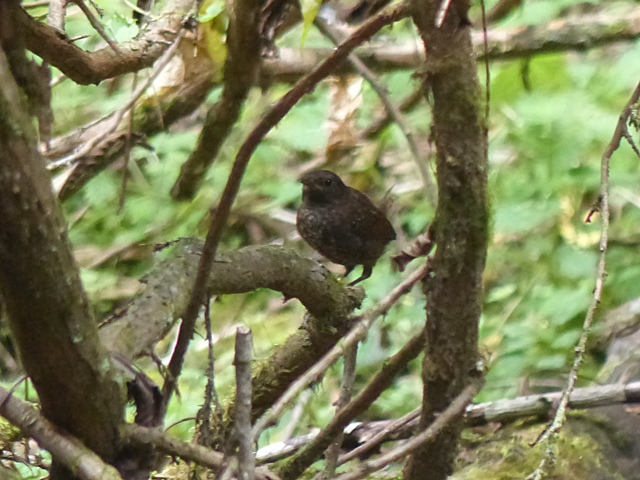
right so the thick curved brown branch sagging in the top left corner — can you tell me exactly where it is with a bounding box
[17,0,194,85]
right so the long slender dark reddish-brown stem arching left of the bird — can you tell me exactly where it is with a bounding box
[163,3,409,408]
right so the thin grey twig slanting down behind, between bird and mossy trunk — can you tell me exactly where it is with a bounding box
[315,17,437,206]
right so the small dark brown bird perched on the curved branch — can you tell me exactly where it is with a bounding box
[296,170,396,285]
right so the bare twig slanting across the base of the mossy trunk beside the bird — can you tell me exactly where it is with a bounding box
[334,378,484,480]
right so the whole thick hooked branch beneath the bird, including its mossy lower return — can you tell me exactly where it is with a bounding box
[100,240,363,452]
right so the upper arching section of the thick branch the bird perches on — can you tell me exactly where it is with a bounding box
[100,239,362,362]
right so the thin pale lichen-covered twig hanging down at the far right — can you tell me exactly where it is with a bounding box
[528,79,640,480]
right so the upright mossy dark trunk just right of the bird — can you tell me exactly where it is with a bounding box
[405,0,489,480]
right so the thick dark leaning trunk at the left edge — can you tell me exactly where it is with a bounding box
[0,0,125,480]
